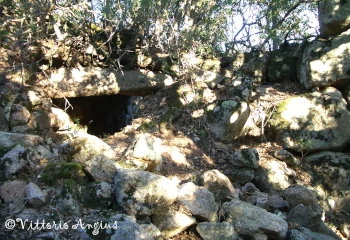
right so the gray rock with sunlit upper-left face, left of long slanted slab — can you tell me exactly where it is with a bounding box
[176,182,219,222]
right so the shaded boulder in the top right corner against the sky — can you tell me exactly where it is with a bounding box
[318,1,350,37]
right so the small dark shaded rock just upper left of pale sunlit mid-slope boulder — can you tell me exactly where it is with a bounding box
[229,148,260,169]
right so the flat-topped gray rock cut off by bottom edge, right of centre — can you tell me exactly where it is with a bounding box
[196,222,238,240]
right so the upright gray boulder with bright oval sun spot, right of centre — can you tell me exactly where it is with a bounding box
[206,100,250,141]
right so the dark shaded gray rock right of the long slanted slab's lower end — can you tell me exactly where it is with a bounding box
[287,204,322,231]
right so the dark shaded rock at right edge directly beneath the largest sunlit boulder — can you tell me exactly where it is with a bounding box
[303,151,350,196]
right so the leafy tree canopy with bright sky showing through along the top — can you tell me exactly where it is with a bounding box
[0,0,318,69]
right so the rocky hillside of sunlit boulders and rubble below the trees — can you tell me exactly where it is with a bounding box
[0,0,350,240]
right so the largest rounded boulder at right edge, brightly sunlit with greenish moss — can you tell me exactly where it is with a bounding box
[268,87,350,153]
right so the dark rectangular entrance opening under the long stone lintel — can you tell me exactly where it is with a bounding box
[52,95,134,137]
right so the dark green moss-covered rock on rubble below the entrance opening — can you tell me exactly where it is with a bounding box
[40,163,88,185]
